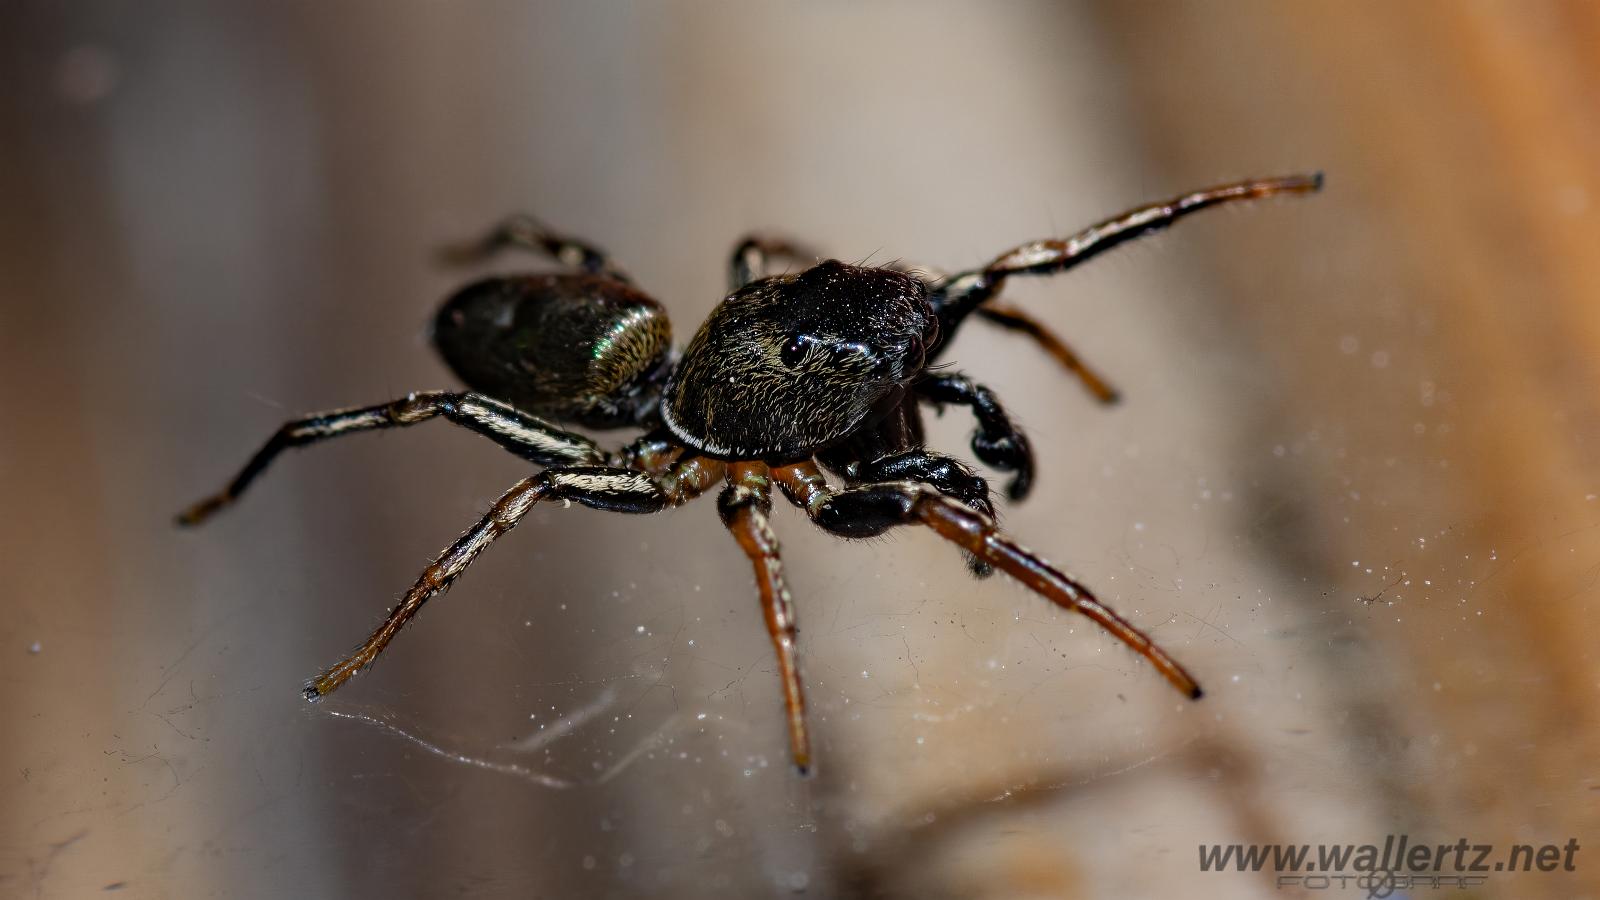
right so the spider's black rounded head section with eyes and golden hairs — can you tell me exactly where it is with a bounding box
[661,259,938,461]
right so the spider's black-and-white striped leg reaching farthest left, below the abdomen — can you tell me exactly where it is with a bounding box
[178,391,605,525]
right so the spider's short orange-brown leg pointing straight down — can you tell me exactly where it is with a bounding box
[717,463,811,775]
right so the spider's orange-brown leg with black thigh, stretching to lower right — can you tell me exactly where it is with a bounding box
[773,463,1200,698]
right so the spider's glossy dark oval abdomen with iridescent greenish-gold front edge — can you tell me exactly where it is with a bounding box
[434,274,672,428]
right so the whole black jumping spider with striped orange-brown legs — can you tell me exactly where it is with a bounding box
[179,175,1322,770]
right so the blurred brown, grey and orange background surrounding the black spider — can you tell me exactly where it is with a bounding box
[0,0,1600,898]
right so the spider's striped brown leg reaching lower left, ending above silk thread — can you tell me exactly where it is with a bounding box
[304,458,723,700]
